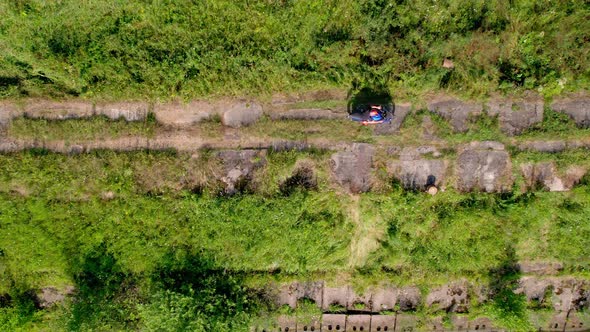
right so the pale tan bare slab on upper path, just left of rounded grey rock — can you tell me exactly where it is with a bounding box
[154,100,222,127]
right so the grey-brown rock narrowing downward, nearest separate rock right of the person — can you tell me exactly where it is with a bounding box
[428,97,483,132]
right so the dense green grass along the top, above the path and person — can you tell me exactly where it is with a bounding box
[0,0,590,99]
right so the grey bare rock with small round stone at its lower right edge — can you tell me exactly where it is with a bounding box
[387,147,449,191]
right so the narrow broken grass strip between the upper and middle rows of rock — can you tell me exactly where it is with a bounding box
[7,102,590,146]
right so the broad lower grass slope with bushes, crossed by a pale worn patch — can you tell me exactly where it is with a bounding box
[0,151,590,330]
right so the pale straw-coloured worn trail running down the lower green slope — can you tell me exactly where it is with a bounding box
[348,195,387,268]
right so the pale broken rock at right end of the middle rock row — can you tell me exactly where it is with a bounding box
[520,162,586,191]
